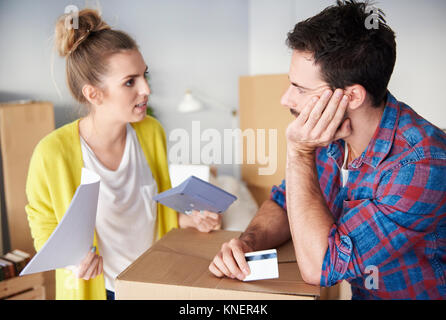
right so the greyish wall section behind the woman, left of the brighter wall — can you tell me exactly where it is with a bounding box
[0,0,249,173]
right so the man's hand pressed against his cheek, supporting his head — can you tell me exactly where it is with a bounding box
[286,89,351,156]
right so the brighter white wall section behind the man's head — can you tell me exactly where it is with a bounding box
[249,0,446,128]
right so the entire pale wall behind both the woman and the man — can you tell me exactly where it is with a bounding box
[0,0,446,178]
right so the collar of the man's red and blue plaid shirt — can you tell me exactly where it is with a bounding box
[327,92,400,169]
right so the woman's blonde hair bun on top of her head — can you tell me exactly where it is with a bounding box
[54,9,110,57]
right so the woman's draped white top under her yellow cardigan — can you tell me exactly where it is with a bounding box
[80,124,157,291]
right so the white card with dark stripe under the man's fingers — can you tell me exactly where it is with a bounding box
[243,249,279,281]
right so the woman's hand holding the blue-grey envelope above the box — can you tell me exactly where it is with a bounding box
[179,210,221,232]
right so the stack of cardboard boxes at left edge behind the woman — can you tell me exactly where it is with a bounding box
[0,101,55,299]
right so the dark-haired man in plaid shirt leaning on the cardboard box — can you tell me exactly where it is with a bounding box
[209,1,446,299]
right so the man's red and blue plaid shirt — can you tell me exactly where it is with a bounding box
[271,93,446,299]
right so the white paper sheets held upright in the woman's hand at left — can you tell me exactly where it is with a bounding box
[20,168,100,276]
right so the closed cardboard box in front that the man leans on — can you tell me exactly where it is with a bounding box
[115,229,320,300]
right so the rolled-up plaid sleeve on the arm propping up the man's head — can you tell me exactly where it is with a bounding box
[320,160,446,286]
